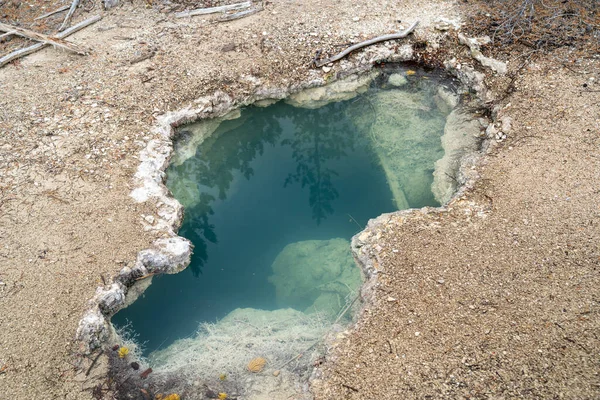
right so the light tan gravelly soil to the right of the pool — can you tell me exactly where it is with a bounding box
[314,56,600,399]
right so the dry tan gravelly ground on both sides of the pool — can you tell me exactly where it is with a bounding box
[0,0,600,399]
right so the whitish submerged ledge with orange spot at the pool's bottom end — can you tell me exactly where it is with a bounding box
[148,308,327,400]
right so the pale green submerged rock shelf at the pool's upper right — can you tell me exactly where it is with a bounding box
[348,87,444,210]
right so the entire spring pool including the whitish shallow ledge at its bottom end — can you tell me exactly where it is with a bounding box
[113,70,460,398]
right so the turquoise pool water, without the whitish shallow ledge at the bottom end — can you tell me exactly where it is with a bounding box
[113,70,447,354]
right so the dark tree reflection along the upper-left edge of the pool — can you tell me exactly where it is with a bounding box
[175,110,282,276]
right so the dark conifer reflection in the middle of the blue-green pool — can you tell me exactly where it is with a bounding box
[282,103,354,224]
